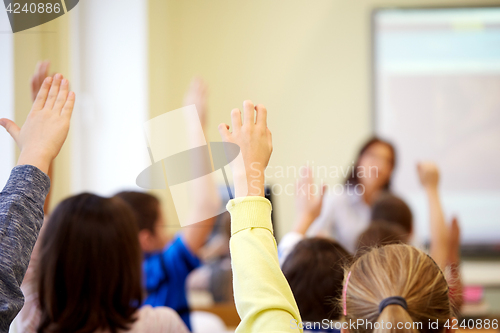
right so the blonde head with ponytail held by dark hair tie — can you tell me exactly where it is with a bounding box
[342,244,452,333]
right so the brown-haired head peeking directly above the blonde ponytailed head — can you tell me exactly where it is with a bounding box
[357,220,409,251]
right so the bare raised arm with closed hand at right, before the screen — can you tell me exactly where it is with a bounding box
[417,162,448,270]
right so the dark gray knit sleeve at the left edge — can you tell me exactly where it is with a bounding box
[0,165,50,333]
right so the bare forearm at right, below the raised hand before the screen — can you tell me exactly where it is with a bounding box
[426,188,448,269]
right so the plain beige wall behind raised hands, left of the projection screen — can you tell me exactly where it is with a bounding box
[150,0,500,236]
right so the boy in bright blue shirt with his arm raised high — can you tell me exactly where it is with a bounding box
[116,79,221,329]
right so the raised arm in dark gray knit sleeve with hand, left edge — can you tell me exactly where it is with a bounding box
[0,74,75,332]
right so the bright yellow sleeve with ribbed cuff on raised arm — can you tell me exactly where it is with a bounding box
[227,197,302,333]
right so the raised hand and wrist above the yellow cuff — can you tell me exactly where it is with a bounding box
[219,101,273,197]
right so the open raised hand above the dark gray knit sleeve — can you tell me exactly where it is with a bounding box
[0,74,75,173]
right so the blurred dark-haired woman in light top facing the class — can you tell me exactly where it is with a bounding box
[307,137,396,253]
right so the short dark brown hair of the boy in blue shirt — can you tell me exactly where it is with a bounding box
[115,191,160,235]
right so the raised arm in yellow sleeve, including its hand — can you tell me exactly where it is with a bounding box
[219,101,302,332]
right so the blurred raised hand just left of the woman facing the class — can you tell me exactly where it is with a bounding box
[294,168,326,235]
